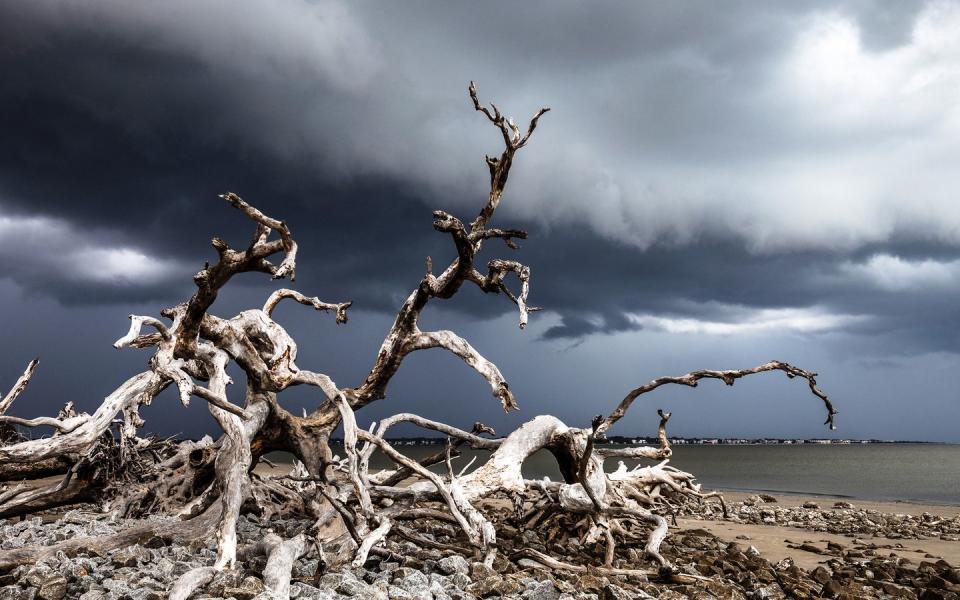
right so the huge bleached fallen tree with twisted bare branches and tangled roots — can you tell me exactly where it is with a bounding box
[0,83,836,598]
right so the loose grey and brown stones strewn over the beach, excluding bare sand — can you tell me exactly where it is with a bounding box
[0,506,960,600]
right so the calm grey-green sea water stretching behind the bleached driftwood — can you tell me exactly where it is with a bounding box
[310,444,960,505]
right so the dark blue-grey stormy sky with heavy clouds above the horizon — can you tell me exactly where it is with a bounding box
[0,0,960,442]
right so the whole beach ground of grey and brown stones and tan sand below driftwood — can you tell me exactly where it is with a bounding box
[0,493,960,600]
